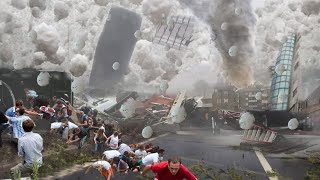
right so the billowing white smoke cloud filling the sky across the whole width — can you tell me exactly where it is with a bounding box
[0,0,320,97]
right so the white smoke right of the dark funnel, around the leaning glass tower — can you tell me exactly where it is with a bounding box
[255,0,320,100]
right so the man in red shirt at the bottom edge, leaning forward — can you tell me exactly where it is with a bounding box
[141,157,197,180]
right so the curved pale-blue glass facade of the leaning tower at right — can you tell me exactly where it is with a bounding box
[271,34,296,111]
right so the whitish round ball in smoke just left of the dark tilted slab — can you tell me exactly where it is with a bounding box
[69,54,88,77]
